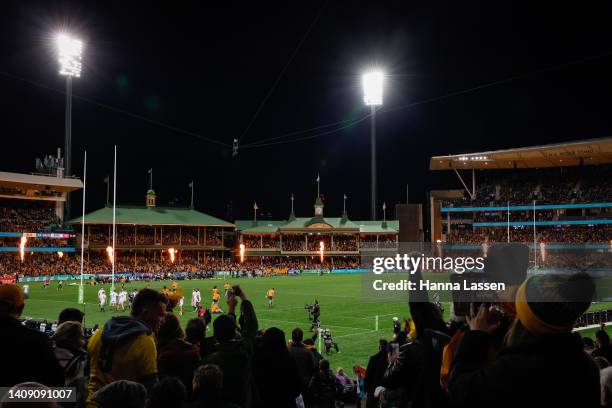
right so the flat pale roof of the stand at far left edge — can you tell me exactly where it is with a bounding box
[0,171,83,201]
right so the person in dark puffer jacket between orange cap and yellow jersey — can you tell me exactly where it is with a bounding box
[51,321,89,406]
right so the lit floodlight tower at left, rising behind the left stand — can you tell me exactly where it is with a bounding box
[56,33,83,218]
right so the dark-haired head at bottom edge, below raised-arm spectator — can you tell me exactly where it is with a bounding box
[189,364,239,408]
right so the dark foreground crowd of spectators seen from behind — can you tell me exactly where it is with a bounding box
[0,246,612,408]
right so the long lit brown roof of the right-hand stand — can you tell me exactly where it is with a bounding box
[429,137,612,170]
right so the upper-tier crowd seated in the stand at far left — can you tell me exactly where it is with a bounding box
[0,199,59,232]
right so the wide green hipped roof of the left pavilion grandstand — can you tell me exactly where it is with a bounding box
[68,207,234,227]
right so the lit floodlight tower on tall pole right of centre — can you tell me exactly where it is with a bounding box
[363,71,385,220]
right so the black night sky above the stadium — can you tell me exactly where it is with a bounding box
[0,0,612,220]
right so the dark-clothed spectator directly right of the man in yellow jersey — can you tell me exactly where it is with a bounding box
[157,312,200,396]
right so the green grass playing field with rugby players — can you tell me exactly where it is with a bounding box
[15,275,612,369]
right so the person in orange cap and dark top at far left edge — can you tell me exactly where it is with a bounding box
[0,285,64,387]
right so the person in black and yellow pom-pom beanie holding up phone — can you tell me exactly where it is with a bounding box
[449,273,600,407]
